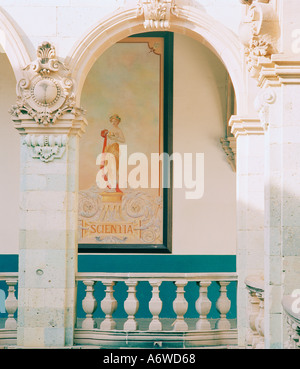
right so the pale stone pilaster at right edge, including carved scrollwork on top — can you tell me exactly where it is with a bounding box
[241,0,300,348]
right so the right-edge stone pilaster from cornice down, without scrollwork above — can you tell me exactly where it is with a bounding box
[259,59,300,349]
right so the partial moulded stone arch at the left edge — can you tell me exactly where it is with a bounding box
[0,8,31,81]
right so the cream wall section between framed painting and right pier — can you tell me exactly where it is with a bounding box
[173,34,236,255]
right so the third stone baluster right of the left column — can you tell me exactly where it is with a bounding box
[124,280,139,332]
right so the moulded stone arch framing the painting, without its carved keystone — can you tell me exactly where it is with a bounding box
[66,7,245,114]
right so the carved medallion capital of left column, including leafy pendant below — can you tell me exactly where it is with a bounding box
[10,42,87,163]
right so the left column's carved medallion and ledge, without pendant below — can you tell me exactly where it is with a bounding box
[10,42,84,134]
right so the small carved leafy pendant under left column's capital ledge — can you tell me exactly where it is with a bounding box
[23,134,68,163]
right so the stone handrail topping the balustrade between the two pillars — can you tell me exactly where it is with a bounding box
[76,272,237,282]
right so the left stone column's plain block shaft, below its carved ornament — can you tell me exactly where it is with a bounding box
[18,117,85,347]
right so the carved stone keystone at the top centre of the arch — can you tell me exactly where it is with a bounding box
[137,0,178,29]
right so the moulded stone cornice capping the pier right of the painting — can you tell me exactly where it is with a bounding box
[229,115,265,138]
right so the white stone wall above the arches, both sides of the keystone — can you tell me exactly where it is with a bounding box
[0,0,243,59]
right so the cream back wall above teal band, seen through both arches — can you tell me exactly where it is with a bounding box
[0,34,236,254]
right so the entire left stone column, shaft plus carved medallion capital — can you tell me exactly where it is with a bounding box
[11,43,86,347]
